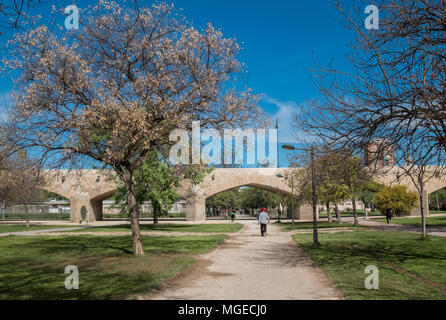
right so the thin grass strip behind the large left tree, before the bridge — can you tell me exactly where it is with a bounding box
[72,223,243,233]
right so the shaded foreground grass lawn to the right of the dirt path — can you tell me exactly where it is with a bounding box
[294,231,446,300]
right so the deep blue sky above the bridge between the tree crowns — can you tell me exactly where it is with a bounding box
[0,0,365,168]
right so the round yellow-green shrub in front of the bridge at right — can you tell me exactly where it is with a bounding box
[376,186,418,217]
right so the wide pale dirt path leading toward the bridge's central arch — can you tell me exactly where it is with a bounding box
[140,221,342,300]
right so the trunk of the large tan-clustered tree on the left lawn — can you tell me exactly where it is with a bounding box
[123,170,144,256]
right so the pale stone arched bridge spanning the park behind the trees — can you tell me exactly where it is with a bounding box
[40,167,446,222]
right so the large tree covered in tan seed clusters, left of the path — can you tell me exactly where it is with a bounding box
[2,1,260,255]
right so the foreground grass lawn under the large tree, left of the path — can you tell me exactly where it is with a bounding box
[0,235,226,300]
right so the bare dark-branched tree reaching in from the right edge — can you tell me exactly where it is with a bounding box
[295,0,446,236]
